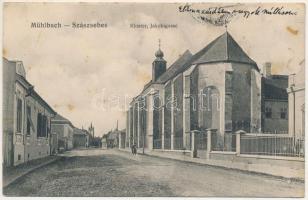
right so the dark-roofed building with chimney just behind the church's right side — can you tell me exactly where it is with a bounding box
[261,63,289,134]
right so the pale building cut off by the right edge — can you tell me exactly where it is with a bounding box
[288,60,305,139]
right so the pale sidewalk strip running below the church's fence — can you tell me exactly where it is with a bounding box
[119,149,305,182]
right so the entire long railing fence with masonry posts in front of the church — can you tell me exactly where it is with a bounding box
[153,129,305,157]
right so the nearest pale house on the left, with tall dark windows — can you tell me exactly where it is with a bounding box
[2,58,56,166]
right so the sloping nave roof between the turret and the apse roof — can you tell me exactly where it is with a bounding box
[156,50,192,83]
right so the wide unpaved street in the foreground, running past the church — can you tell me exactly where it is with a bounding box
[3,150,304,197]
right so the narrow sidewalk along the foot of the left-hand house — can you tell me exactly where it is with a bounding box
[2,156,60,188]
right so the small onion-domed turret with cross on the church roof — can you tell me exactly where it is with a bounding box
[152,40,167,82]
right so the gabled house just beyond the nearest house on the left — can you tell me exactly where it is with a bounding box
[51,114,74,150]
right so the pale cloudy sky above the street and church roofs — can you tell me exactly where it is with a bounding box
[3,3,304,135]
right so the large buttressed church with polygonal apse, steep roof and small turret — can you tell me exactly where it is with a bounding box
[125,32,262,150]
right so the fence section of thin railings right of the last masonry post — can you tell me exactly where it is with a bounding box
[240,134,305,157]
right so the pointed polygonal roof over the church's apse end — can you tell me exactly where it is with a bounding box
[192,32,259,71]
